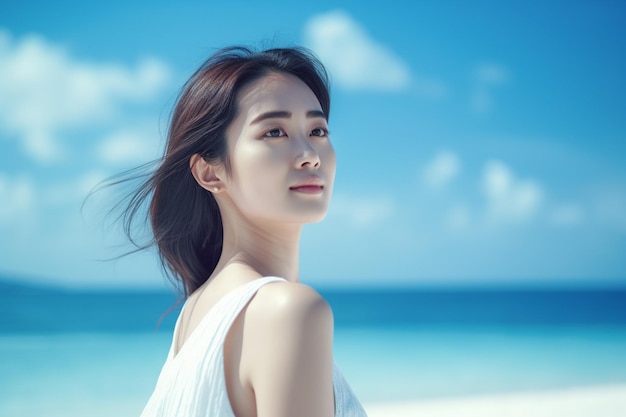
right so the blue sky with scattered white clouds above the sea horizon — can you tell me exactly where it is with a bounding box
[0,1,626,287]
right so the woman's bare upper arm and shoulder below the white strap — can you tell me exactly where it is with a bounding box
[241,282,335,417]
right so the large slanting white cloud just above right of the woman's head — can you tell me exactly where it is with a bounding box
[305,11,410,91]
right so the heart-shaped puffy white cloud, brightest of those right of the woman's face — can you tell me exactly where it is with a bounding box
[483,161,543,223]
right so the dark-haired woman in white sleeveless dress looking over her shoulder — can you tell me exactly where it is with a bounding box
[127,48,365,417]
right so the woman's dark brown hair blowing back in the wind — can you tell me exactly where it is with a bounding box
[122,47,330,296]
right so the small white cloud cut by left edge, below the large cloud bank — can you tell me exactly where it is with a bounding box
[0,174,35,225]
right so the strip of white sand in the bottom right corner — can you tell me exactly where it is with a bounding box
[366,385,626,417]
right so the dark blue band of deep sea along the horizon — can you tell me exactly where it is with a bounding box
[0,279,626,333]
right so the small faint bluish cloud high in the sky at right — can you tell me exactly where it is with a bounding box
[470,64,511,114]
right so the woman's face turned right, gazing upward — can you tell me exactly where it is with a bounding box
[223,73,336,223]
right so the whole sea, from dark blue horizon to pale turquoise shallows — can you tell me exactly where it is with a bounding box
[0,282,626,417]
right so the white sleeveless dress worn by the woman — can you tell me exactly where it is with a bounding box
[141,277,367,417]
